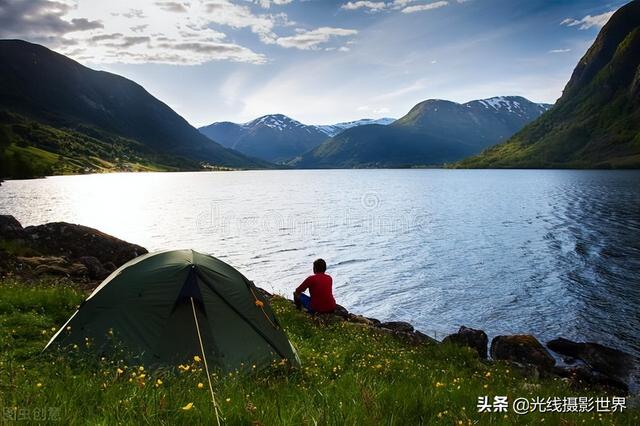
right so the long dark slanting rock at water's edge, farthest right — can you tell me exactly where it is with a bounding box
[547,337,634,383]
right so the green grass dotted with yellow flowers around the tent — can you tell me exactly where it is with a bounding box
[0,278,640,425]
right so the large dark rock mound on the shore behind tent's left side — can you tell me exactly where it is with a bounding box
[24,222,147,265]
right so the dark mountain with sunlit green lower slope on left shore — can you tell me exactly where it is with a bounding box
[0,40,265,177]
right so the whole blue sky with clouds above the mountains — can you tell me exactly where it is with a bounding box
[0,0,626,126]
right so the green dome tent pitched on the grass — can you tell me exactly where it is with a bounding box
[45,250,299,372]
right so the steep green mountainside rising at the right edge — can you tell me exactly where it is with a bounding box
[458,0,640,168]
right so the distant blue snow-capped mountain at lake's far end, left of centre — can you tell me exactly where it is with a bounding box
[198,114,327,162]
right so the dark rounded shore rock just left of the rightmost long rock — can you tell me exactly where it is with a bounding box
[491,334,556,370]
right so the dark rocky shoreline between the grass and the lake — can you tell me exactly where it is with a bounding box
[0,215,637,394]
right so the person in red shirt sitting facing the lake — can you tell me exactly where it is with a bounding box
[293,259,336,314]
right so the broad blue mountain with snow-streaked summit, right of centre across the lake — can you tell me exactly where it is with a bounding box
[291,96,549,168]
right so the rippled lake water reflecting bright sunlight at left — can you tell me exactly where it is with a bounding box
[0,170,640,366]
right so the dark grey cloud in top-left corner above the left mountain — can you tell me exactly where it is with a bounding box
[0,0,103,42]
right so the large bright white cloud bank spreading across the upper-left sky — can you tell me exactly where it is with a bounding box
[0,0,310,65]
